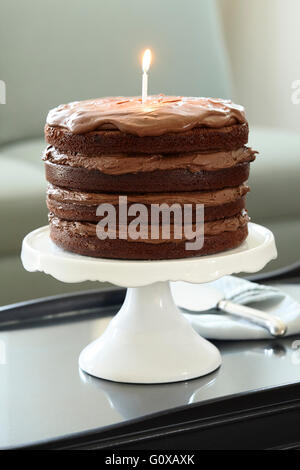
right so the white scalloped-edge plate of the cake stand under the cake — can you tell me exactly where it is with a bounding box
[21,223,277,287]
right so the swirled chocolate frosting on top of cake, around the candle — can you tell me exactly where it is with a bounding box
[47,95,247,137]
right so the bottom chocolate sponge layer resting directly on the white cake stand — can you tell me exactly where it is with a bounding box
[50,217,248,260]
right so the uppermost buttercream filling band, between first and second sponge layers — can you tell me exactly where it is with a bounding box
[43,146,257,175]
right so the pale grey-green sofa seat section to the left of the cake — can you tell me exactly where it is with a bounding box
[0,139,47,256]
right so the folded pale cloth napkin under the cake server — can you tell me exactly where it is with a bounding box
[180,276,300,340]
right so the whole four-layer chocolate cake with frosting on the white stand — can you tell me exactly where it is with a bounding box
[43,95,256,260]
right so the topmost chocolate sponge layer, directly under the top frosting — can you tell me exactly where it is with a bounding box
[45,122,249,155]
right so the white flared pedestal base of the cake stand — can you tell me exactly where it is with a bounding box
[79,282,221,383]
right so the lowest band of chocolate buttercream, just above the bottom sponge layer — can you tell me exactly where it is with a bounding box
[49,210,249,244]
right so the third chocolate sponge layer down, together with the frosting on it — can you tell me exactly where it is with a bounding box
[47,185,249,223]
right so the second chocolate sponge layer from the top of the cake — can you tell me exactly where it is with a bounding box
[45,161,250,194]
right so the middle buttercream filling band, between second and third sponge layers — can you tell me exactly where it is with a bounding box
[47,184,250,206]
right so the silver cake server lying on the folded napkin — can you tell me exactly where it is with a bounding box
[171,282,287,337]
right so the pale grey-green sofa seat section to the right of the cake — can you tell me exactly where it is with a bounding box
[247,126,300,221]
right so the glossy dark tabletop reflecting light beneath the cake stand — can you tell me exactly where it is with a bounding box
[0,268,300,448]
